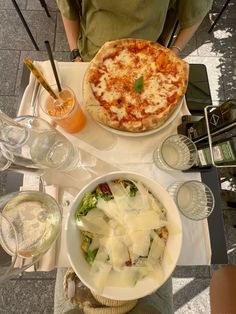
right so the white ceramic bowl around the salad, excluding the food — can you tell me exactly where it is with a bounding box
[66,171,182,300]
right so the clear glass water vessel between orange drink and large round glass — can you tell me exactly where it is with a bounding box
[0,116,79,171]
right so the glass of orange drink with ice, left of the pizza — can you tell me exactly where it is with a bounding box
[39,86,86,133]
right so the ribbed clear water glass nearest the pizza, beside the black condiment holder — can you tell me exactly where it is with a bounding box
[153,134,197,170]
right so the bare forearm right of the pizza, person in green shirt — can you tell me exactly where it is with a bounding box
[171,21,202,55]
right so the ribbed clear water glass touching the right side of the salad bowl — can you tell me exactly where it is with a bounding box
[167,180,215,220]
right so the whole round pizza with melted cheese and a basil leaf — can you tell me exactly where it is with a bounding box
[83,38,189,132]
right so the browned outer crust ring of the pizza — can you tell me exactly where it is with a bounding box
[83,39,189,132]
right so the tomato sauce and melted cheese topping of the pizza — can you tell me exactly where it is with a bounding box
[85,40,186,129]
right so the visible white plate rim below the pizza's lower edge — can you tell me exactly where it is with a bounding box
[94,97,184,137]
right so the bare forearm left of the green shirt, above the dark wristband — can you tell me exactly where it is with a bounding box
[61,15,80,51]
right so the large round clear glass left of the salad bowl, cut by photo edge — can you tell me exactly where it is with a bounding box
[0,191,62,282]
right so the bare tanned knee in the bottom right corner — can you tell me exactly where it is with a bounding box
[210,265,236,314]
